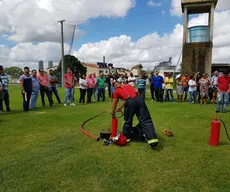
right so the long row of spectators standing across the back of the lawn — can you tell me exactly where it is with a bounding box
[0,66,230,112]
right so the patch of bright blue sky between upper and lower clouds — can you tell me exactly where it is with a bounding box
[71,0,183,49]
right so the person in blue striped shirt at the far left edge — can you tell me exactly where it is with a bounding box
[0,66,10,112]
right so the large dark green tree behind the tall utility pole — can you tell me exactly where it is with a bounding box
[54,55,86,83]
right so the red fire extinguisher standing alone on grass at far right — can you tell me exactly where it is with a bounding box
[209,118,221,146]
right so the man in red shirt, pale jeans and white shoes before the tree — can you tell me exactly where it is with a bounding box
[64,67,75,106]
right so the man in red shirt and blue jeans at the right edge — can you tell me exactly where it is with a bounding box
[216,71,230,113]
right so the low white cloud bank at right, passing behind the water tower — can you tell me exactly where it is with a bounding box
[75,10,230,67]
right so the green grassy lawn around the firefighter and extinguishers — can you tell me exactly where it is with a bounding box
[0,86,230,192]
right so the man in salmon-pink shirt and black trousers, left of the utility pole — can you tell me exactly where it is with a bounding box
[37,69,53,107]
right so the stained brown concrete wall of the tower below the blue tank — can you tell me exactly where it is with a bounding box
[182,42,213,75]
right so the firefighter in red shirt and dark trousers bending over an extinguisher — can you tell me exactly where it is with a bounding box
[112,82,158,148]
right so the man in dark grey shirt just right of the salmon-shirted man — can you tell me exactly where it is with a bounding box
[49,69,61,104]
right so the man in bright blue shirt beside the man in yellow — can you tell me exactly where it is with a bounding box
[152,71,164,102]
